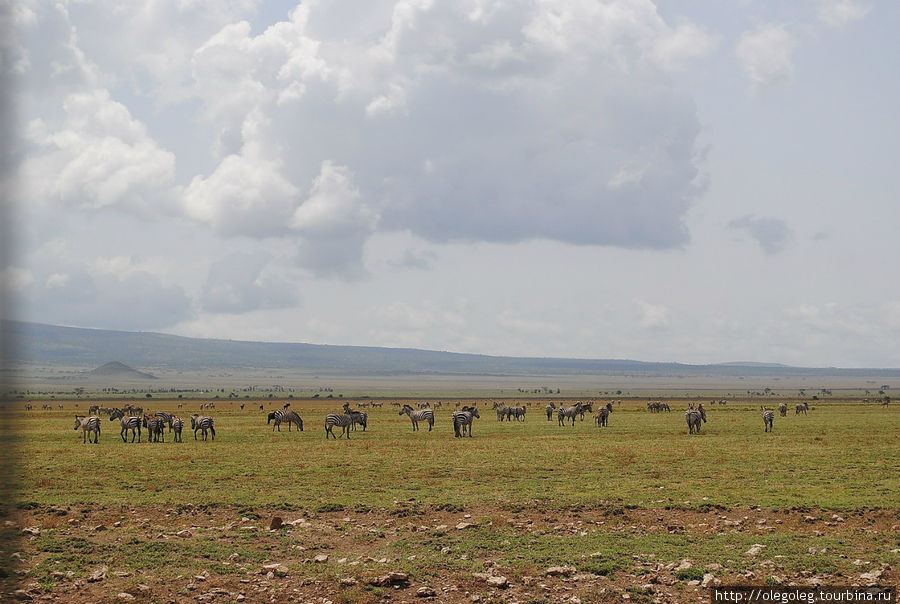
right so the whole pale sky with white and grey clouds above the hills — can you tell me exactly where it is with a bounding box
[0,0,900,367]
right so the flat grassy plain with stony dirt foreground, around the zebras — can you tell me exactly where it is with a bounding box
[0,396,900,603]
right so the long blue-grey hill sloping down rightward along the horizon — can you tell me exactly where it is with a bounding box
[0,321,900,377]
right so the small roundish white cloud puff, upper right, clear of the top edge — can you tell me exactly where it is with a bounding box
[735,24,797,86]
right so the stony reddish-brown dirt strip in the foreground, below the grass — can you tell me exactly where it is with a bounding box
[3,506,900,604]
